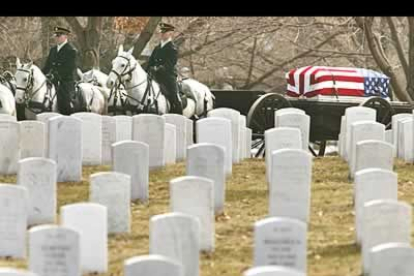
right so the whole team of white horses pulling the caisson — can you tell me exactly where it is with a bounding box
[0,45,214,119]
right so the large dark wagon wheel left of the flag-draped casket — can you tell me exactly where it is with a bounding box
[247,93,292,157]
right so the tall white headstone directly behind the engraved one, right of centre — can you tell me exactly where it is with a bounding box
[269,149,312,223]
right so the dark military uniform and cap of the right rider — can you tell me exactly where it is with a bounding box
[147,23,183,114]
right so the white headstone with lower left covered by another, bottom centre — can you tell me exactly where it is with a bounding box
[170,176,215,252]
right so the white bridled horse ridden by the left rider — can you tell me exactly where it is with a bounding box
[15,59,106,119]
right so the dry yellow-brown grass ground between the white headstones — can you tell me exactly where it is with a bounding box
[0,156,414,276]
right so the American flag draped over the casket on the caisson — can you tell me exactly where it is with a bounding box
[286,66,390,99]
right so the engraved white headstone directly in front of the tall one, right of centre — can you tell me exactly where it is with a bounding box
[253,217,307,272]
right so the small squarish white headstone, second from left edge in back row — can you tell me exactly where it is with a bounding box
[19,121,46,159]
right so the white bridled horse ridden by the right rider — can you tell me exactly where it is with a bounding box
[107,45,214,118]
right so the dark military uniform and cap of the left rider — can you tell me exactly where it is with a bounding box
[43,27,78,115]
